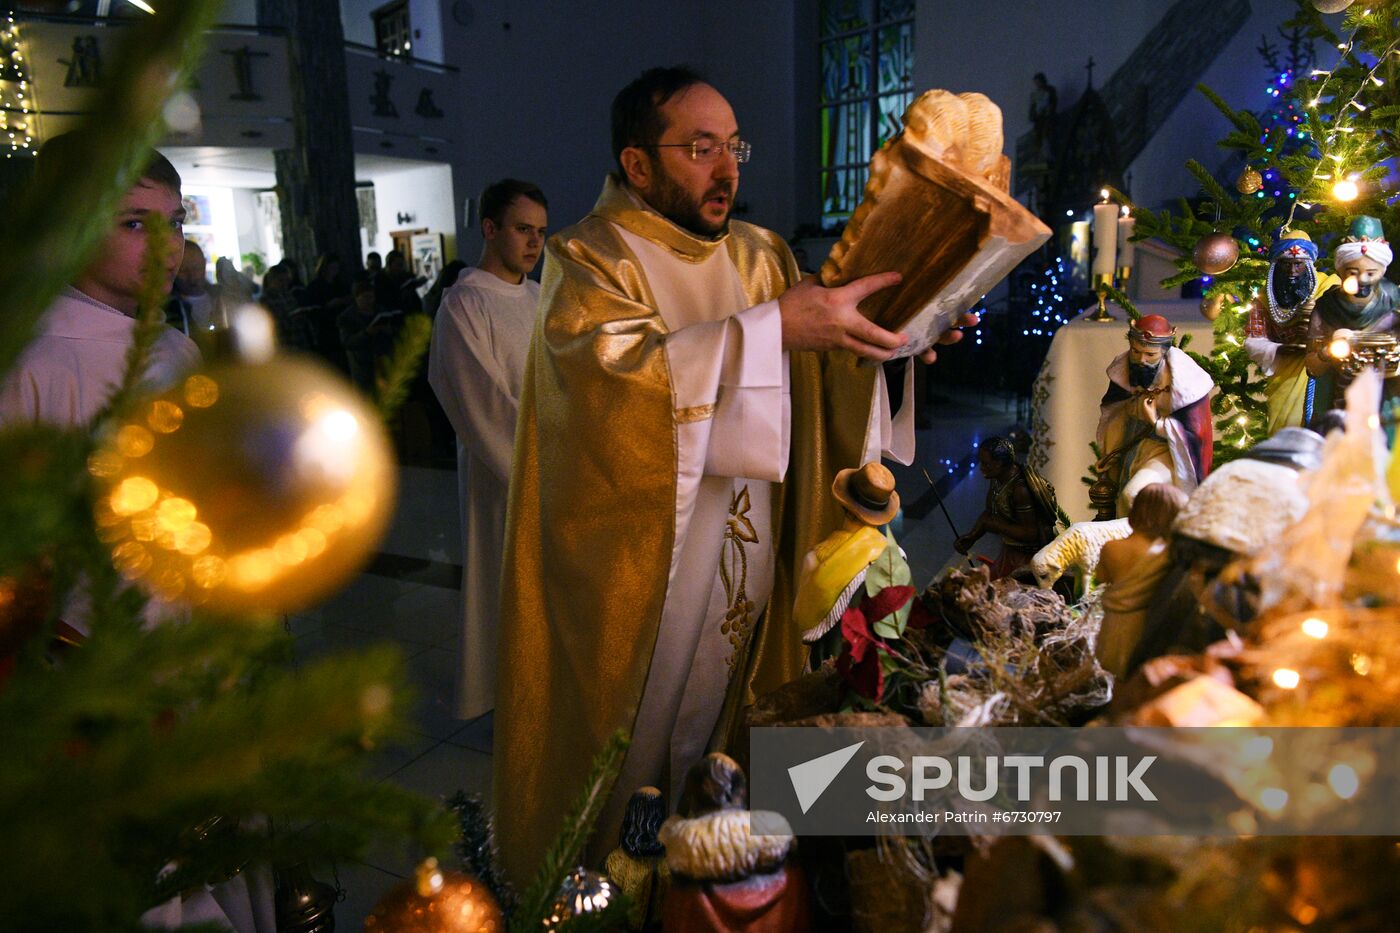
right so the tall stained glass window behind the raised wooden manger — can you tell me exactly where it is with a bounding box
[819,0,914,228]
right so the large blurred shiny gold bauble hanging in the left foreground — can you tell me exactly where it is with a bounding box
[88,357,396,614]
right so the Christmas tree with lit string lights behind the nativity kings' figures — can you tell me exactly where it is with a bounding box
[1134,0,1400,462]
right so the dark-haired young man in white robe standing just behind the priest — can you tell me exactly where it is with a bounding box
[428,178,549,719]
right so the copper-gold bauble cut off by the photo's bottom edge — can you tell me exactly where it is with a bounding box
[364,859,505,933]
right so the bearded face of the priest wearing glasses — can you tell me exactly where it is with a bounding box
[637,84,739,237]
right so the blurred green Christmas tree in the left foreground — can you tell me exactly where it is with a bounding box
[0,0,454,930]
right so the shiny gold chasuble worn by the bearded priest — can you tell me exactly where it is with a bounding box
[494,178,879,885]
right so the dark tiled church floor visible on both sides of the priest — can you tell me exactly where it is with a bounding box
[290,381,1014,930]
